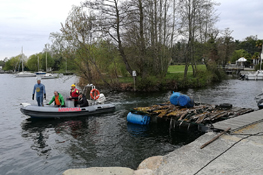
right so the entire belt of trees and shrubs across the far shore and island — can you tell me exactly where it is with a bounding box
[3,0,263,89]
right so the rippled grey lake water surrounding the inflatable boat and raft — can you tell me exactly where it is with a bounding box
[0,75,263,175]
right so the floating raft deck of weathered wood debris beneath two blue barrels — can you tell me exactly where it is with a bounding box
[131,102,254,127]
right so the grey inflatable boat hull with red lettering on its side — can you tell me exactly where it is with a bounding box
[20,104,115,118]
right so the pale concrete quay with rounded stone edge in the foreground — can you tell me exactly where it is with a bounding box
[63,110,263,175]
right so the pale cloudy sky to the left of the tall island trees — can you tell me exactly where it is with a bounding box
[0,0,81,60]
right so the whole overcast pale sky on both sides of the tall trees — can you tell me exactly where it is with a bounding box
[0,0,263,60]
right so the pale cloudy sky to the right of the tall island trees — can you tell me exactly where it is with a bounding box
[216,0,263,40]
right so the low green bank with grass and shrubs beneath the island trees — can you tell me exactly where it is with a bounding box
[78,64,227,92]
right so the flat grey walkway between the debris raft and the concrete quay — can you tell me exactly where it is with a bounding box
[213,110,263,131]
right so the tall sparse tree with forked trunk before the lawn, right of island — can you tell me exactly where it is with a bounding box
[178,0,221,78]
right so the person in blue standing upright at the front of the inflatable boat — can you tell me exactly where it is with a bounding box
[32,78,46,106]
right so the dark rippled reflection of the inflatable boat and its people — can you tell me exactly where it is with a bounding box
[21,118,99,157]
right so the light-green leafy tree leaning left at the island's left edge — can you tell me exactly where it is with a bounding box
[61,7,114,87]
